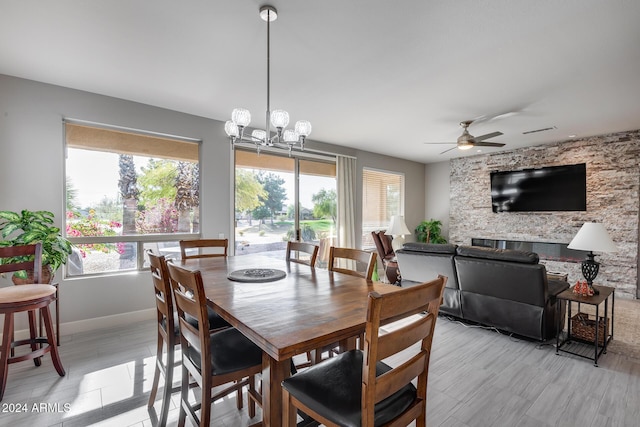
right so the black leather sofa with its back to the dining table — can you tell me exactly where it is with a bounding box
[396,243,569,341]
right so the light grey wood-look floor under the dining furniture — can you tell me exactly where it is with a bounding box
[0,318,640,427]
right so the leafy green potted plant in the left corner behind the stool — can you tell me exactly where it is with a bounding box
[0,210,71,283]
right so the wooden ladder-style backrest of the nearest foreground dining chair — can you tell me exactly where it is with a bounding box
[362,276,447,426]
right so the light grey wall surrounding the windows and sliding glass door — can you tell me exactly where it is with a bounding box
[0,75,425,334]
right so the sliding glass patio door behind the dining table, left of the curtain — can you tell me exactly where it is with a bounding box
[235,149,337,264]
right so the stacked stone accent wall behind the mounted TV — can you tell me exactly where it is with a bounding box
[449,130,640,298]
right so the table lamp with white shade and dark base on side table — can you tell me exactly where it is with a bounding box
[567,222,617,295]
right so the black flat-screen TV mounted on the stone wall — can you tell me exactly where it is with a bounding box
[491,163,587,212]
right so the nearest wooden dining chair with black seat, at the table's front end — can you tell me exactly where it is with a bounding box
[282,276,447,427]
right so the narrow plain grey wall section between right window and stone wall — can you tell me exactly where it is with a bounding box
[424,161,450,241]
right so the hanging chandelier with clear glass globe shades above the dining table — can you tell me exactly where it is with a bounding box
[224,5,311,156]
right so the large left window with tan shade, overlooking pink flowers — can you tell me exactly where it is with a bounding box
[65,121,200,276]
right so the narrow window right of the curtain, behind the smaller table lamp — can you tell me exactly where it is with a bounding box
[362,168,404,248]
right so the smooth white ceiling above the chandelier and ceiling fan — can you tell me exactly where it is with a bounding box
[0,0,640,163]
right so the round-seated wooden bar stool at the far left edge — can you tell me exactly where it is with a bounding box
[0,243,66,400]
